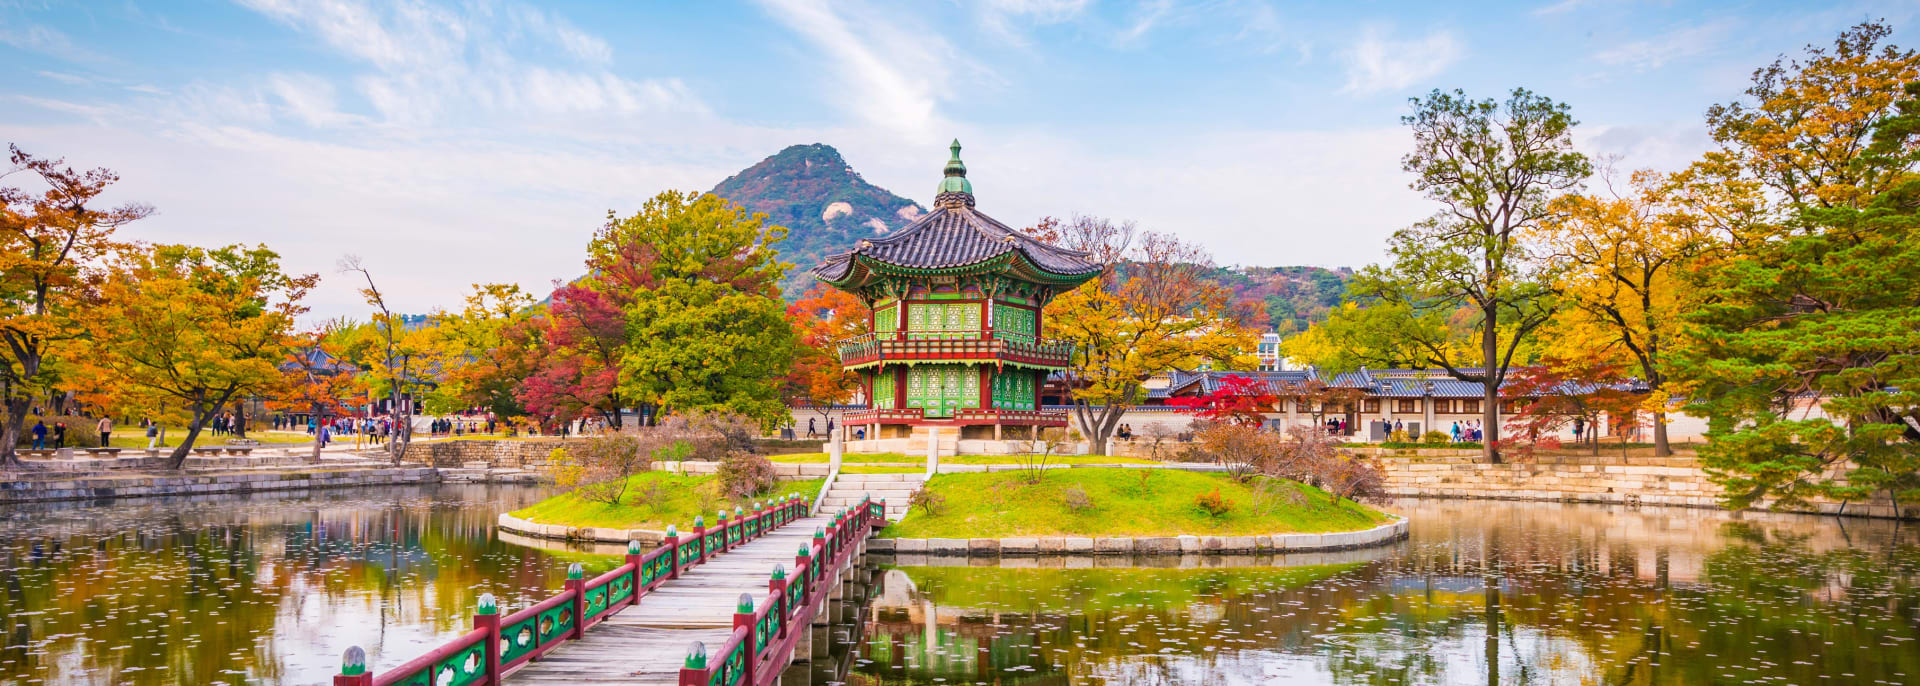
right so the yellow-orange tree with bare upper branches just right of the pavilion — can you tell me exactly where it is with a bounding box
[1029,224,1254,455]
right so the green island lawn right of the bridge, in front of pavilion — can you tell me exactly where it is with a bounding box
[881,467,1386,538]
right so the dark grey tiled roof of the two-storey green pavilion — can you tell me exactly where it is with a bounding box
[814,208,1100,281]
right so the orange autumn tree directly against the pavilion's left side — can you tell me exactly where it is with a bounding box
[785,284,874,419]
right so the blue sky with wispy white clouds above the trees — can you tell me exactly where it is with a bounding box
[0,0,1920,317]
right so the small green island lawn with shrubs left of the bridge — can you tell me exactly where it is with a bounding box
[513,471,826,530]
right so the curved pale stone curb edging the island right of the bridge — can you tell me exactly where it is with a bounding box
[875,515,1409,557]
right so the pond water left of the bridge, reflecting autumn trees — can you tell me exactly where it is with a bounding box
[0,486,614,684]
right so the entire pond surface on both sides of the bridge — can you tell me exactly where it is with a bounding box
[0,484,1920,684]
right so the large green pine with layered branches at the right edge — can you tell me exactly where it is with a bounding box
[1680,85,1920,507]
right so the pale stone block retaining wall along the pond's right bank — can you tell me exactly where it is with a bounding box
[1379,455,1920,517]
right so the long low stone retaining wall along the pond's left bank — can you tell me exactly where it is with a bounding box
[0,467,440,505]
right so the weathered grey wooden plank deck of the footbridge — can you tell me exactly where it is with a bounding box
[507,517,831,684]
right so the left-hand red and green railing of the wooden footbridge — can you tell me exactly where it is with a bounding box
[334,494,867,686]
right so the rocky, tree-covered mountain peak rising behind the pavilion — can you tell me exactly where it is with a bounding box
[710,142,925,298]
